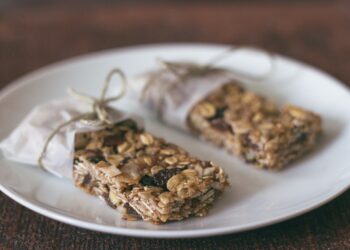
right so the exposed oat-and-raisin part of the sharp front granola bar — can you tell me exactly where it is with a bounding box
[73,119,228,224]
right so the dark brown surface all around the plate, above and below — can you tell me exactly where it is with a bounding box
[0,0,350,249]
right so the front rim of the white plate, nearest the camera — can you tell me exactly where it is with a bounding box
[0,178,350,239]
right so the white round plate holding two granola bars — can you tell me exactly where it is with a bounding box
[0,44,350,238]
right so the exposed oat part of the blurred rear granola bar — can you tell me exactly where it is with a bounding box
[188,82,321,169]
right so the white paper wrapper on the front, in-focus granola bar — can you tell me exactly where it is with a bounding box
[0,98,143,178]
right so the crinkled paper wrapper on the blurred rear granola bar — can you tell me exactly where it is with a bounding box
[131,63,237,131]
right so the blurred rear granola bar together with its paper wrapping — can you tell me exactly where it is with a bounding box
[134,54,321,169]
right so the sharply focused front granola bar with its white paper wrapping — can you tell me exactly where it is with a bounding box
[0,69,228,224]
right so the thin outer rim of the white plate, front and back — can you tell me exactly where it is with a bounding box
[0,43,350,238]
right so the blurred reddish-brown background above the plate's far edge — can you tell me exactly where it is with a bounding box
[0,0,350,89]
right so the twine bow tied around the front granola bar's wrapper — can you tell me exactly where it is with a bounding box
[38,69,127,170]
